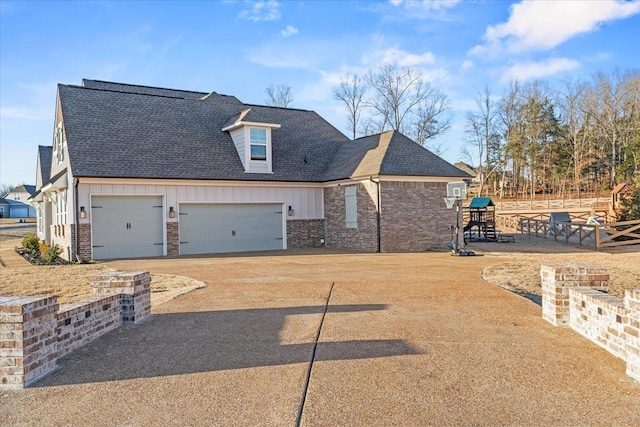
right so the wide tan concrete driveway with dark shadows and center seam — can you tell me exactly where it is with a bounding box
[0,252,640,426]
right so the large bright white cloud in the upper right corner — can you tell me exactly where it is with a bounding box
[471,0,640,54]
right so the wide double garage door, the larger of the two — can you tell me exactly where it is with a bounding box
[180,203,284,254]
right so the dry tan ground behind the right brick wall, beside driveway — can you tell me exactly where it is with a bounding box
[469,235,640,297]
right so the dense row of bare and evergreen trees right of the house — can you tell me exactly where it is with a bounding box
[464,69,640,198]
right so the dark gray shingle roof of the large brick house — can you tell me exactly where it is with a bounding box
[57,80,467,182]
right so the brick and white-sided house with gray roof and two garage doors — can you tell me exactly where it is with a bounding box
[32,80,468,260]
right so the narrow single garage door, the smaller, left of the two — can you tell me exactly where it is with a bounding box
[91,196,164,259]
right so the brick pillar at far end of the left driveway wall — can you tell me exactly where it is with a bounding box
[91,271,151,323]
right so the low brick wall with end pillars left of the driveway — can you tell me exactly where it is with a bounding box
[0,272,151,389]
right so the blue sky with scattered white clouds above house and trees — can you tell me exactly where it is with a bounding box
[0,0,640,184]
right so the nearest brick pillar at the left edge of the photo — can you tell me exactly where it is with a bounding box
[0,296,58,388]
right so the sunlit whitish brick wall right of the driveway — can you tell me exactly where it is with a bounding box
[541,265,640,381]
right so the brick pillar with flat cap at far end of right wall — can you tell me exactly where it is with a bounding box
[540,265,609,326]
